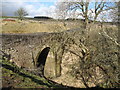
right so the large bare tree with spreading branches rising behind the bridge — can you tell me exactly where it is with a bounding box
[56,0,114,28]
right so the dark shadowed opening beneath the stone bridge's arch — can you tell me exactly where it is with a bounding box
[36,47,50,76]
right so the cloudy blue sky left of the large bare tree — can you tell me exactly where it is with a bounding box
[2,0,115,19]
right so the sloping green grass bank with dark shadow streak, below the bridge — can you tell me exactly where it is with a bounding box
[0,60,64,88]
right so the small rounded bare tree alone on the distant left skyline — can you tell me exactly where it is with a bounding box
[15,7,28,21]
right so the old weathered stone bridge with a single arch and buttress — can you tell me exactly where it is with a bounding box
[1,30,87,77]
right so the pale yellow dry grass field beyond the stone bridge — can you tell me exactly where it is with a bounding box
[0,20,80,33]
